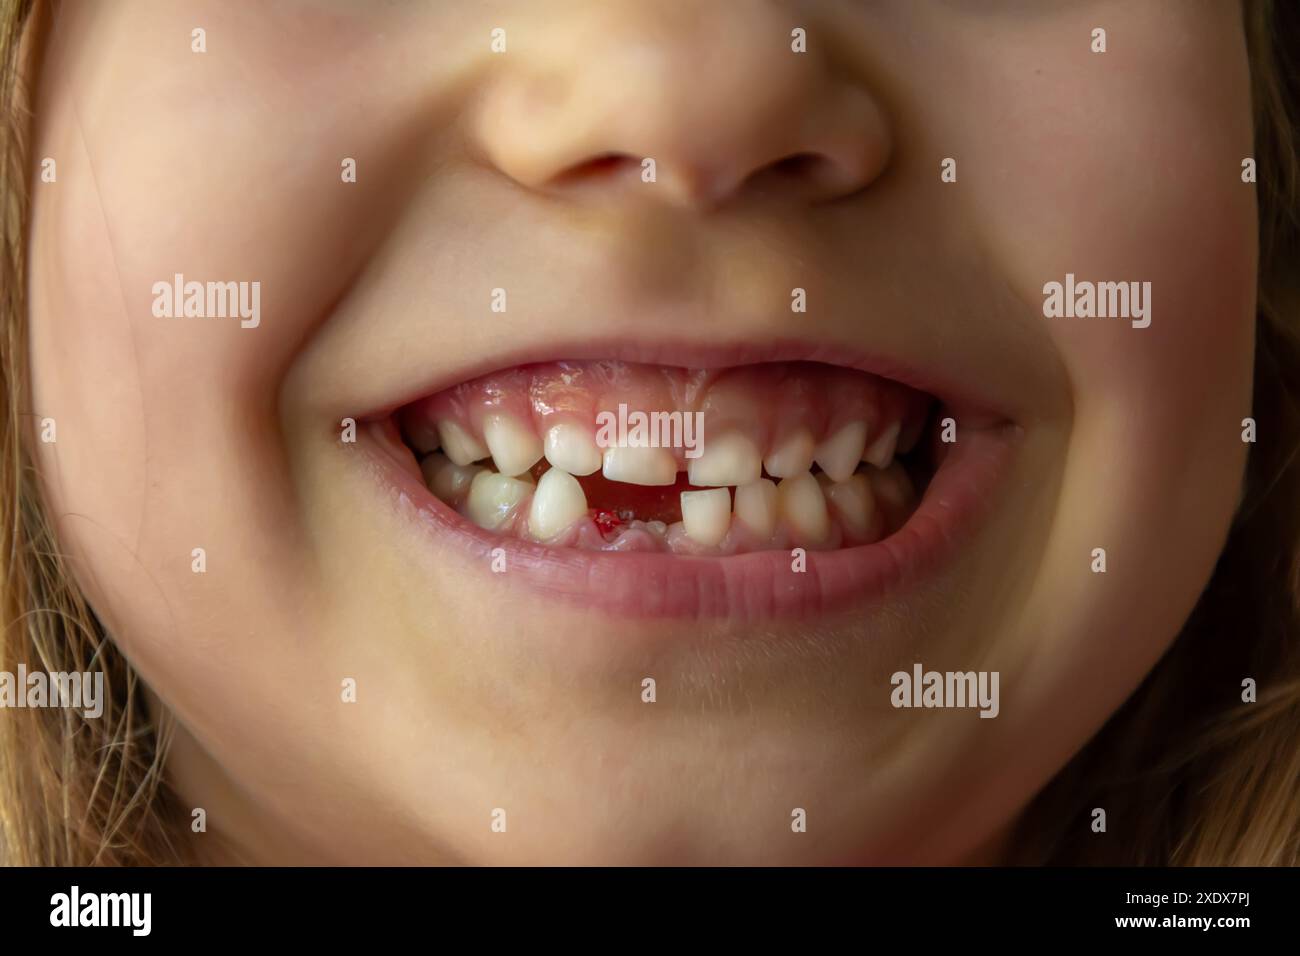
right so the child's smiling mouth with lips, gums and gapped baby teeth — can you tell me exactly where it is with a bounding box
[360,359,1019,619]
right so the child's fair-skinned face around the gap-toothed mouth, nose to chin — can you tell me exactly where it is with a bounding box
[30,0,1256,862]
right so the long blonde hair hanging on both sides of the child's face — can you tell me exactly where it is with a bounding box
[0,0,1300,866]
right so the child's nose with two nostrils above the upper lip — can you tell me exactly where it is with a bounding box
[473,0,891,209]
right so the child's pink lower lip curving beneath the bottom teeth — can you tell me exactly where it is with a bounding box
[364,425,1021,623]
